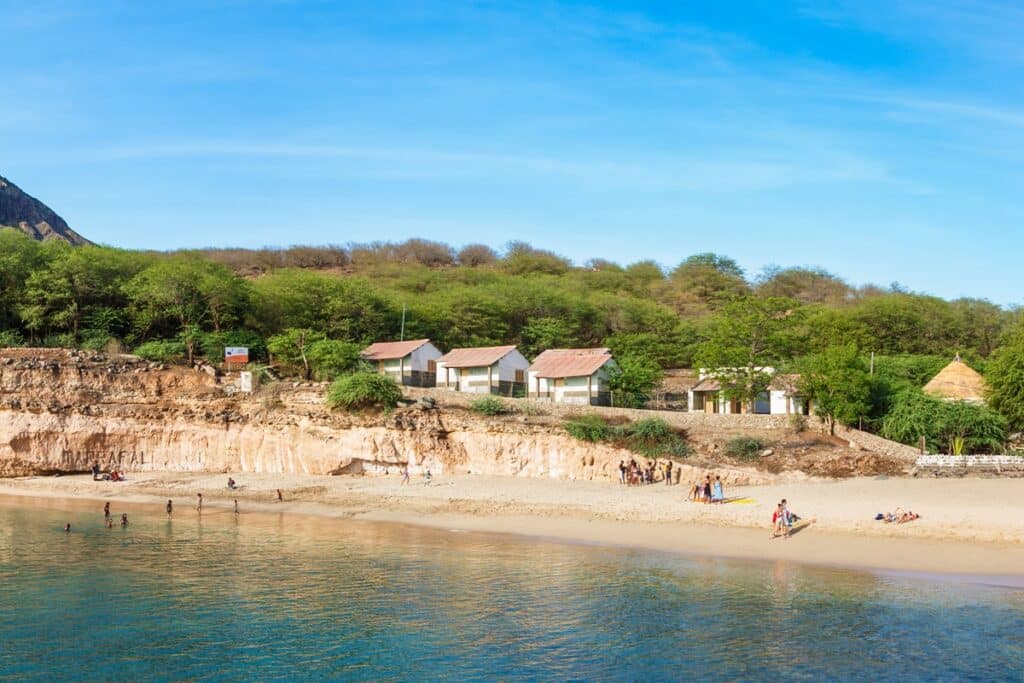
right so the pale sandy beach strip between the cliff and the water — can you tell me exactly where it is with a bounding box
[0,472,1024,585]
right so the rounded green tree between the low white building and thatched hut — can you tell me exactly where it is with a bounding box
[797,344,871,433]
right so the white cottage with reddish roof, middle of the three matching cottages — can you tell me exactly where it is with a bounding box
[435,346,529,396]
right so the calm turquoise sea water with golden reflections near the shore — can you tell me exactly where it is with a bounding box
[0,501,1024,681]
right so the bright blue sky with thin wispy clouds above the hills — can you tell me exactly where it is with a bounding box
[0,0,1024,304]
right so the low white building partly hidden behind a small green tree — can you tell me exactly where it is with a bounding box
[689,368,813,415]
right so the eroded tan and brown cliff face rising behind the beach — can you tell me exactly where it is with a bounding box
[0,349,897,483]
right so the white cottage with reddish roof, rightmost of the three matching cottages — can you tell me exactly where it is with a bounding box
[526,348,616,405]
